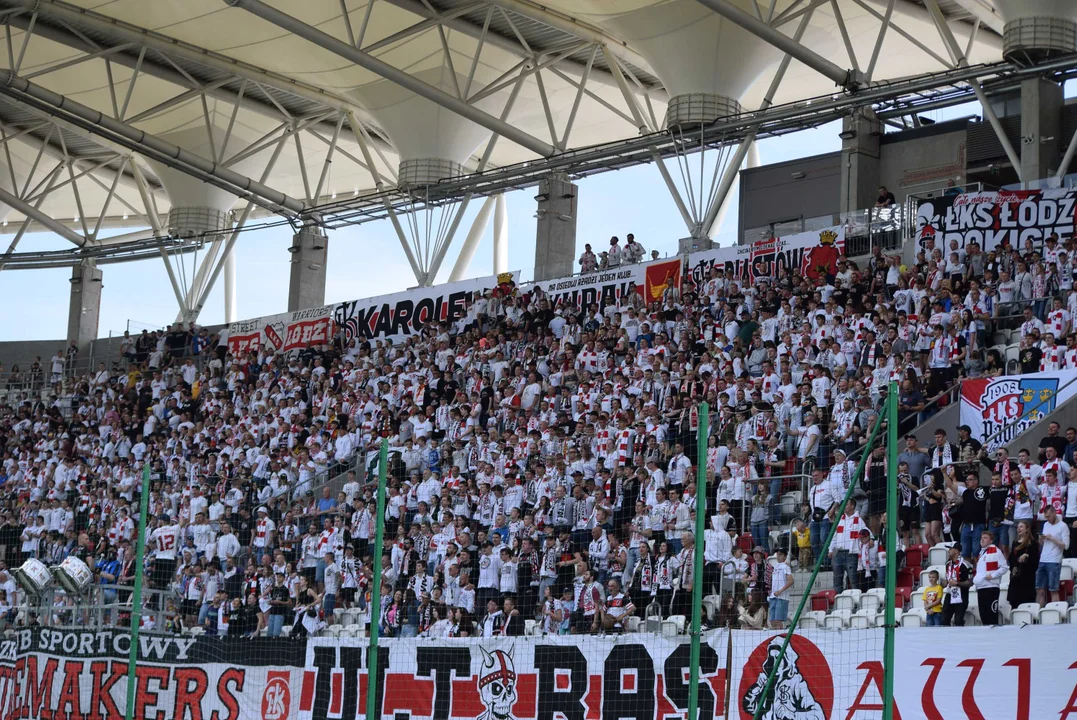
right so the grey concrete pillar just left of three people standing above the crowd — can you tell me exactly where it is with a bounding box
[535,174,577,280]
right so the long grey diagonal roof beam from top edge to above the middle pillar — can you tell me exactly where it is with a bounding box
[224,0,556,157]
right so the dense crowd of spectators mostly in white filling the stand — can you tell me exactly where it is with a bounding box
[0,224,1077,636]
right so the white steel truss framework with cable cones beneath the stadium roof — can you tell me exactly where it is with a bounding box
[0,0,1042,294]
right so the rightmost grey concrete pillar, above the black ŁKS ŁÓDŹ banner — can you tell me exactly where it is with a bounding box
[1018,77,1068,183]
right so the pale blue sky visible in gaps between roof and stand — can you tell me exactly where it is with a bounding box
[0,96,999,340]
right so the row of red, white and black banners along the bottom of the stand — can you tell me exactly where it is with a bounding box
[0,624,1077,720]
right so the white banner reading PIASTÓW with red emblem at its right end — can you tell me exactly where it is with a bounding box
[688,225,845,287]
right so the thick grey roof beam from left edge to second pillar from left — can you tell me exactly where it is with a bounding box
[0,70,306,213]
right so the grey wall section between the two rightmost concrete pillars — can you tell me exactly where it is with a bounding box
[878,119,968,202]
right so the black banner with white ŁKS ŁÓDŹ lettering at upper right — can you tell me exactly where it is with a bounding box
[915,189,1077,259]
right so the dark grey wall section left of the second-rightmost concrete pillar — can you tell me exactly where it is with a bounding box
[739,153,841,238]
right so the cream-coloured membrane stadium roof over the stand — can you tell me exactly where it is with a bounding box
[0,0,1051,288]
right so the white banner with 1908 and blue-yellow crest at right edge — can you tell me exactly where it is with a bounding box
[961,370,1077,453]
